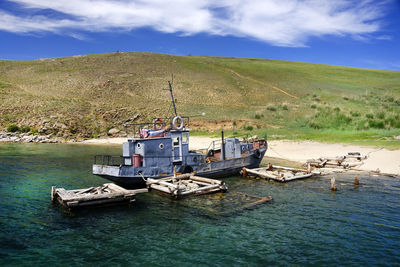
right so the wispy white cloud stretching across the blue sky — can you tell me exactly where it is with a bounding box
[0,0,391,46]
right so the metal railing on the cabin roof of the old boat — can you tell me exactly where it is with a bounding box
[124,116,190,138]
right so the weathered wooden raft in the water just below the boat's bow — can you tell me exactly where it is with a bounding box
[241,164,316,182]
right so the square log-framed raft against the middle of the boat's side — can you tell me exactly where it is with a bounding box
[146,173,228,198]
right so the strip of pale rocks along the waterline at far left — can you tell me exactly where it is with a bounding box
[0,132,69,143]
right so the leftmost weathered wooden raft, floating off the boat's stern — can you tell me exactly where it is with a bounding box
[51,183,148,209]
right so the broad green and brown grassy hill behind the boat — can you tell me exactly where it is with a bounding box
[0,53,400,146]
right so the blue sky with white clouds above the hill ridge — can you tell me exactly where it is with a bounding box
[0,0,400,71]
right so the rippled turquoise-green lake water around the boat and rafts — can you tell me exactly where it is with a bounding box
[0,144,400,266]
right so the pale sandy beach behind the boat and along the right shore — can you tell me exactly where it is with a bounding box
[82,136,400,175]
